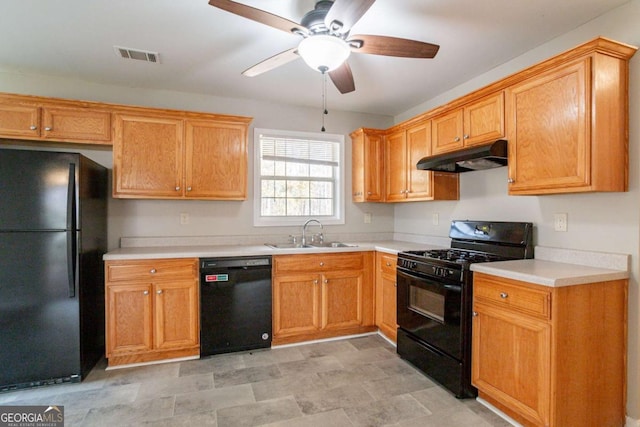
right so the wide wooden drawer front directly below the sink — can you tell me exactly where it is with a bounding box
[273,252,364,273]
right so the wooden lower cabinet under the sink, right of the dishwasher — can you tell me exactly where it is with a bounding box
[273,252,376,345]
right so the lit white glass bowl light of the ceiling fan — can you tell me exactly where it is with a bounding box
[298,34,351,72]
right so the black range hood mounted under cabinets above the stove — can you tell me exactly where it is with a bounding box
[416,139,507,172]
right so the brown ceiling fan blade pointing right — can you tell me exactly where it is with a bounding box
[347,34,440,58]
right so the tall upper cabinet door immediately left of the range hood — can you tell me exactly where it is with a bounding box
[406,122,433,200]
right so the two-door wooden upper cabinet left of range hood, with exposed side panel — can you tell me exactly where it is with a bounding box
[384,121,459,202]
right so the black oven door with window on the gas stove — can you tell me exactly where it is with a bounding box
[397,267,463,360]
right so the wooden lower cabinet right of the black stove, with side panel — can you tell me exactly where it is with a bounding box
[472,272,628,427]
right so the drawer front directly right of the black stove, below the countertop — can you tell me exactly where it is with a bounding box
[473,274,551,319]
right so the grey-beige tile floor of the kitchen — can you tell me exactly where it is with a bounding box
[0,335,509,427]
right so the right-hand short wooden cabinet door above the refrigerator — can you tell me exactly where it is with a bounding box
[42,107,111,144]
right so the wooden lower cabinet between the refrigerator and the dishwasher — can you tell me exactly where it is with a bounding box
[105,258,200,366]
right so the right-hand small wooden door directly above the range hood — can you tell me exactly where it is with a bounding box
[463,92,504,146]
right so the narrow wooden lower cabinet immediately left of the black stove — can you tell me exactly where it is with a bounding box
[376,252,398,342]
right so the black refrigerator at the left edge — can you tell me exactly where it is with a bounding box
[0,148,108,391]
